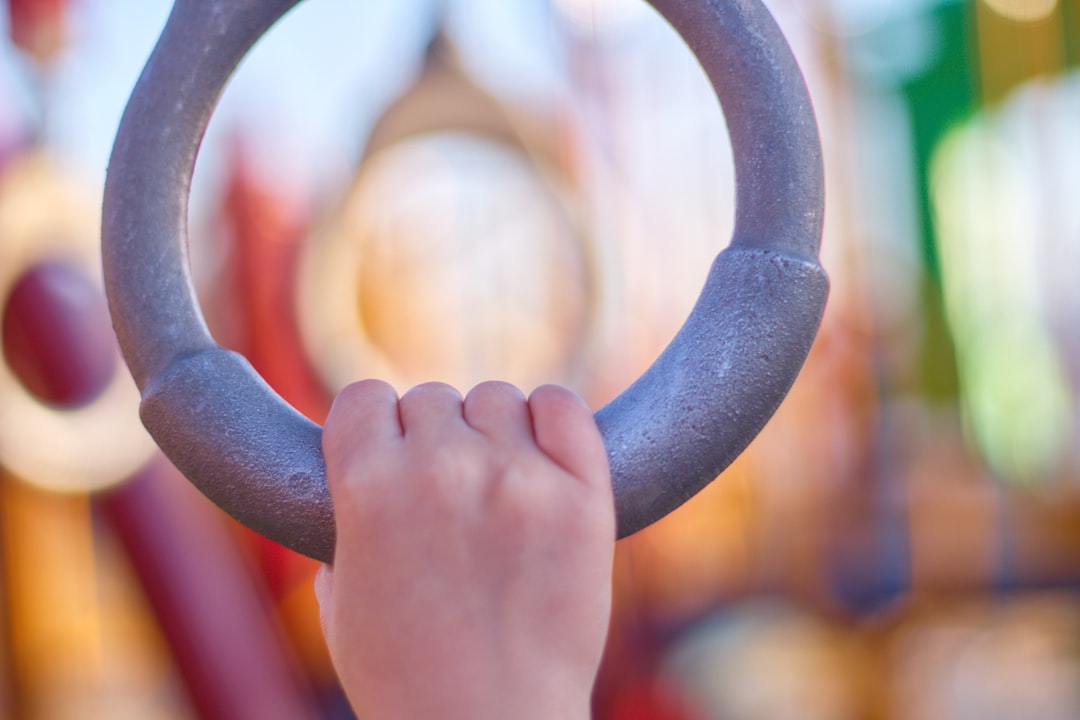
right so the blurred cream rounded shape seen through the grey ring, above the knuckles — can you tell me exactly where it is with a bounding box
[300,132,589,391]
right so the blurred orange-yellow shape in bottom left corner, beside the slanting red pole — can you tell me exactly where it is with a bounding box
[0,473,190,720]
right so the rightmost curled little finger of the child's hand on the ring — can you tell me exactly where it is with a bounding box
[529,385,610,484]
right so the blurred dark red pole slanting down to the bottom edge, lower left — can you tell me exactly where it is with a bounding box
[97,458,319,720]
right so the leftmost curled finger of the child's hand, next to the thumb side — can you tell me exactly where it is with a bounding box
[323,380,402,475]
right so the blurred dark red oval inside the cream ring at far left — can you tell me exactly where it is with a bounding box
[3,260,118,409]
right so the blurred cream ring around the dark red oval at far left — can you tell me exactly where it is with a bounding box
[0,152,153,491]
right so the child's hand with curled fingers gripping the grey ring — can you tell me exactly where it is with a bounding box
[316,381,616,720]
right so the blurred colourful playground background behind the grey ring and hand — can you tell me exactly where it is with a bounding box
[0,0,1080,720]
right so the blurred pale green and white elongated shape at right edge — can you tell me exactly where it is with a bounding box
[931,116,1072,483]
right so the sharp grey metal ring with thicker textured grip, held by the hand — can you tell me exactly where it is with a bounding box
[103,0,828,561]
